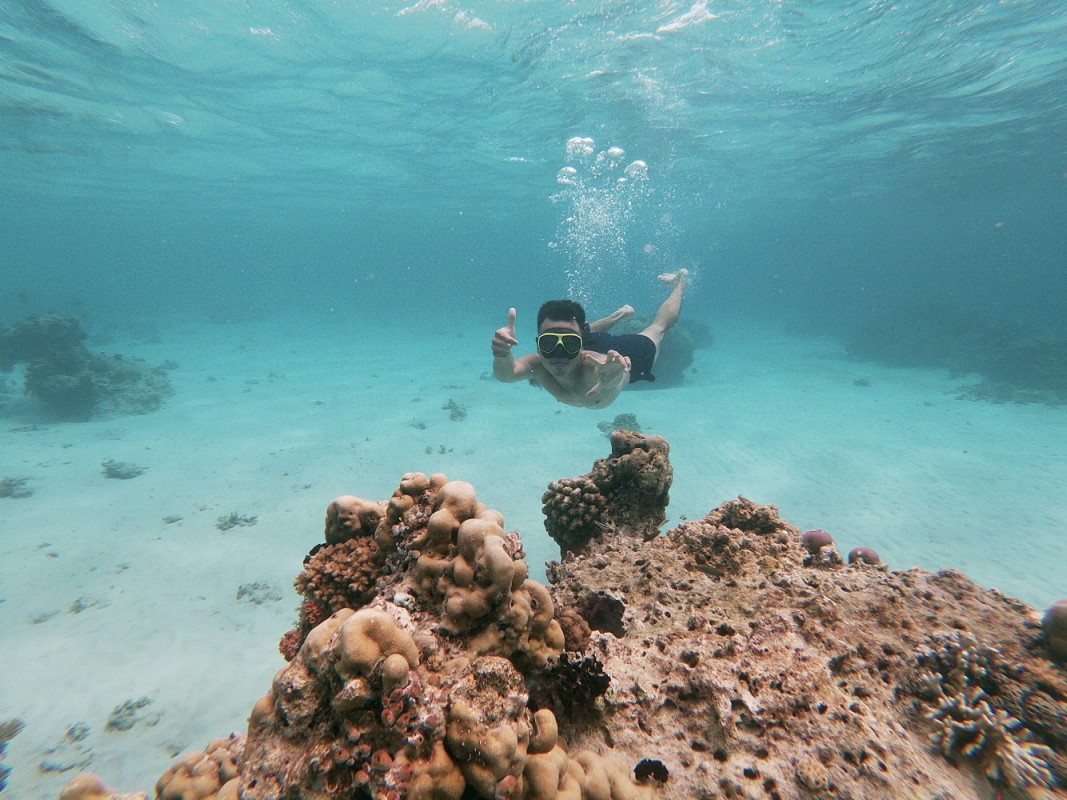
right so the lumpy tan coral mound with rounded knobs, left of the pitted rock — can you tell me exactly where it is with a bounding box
[236,474,651,800]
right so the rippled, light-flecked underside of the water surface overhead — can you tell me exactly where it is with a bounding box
[0,0,1067,214]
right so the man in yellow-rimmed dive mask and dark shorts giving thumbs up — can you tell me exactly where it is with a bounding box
[493,270,689,409]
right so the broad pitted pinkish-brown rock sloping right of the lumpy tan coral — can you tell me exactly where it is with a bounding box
[550,480,1067,800]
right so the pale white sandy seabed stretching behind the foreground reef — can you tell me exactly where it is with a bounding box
[0,311,1067,800]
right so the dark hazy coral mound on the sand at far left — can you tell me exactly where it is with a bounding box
[0,315,174,420]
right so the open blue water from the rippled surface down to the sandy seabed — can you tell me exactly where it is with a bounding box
[0,0,1067,332]
